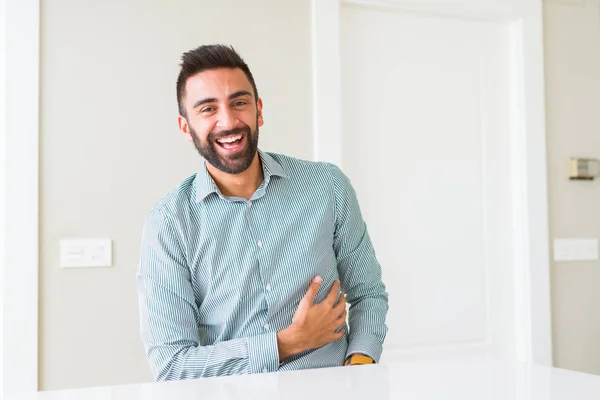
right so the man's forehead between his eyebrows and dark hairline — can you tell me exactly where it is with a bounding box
[185,68,254,104]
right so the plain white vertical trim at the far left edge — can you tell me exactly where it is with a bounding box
[0,0,40,397]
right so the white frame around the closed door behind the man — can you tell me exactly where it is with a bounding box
[312,0,552,366]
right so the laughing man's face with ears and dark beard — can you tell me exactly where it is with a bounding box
[178,68,263,174]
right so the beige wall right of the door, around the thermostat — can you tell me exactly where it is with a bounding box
[544,0,600,374]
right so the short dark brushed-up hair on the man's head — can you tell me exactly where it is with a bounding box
[177,44,258,117]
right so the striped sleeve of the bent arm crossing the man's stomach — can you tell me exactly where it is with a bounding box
[137,209,279,380]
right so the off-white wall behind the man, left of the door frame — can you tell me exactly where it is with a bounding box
[39,0,312,390]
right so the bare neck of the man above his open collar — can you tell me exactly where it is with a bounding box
[206,152,264,200]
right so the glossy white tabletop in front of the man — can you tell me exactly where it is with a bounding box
[7,359,600,400]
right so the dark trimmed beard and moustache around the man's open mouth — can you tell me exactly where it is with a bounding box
[189,121,258,175]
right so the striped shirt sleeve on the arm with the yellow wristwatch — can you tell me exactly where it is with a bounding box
[331,165,388,362]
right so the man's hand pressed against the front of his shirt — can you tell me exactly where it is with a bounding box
[277,275,346,361]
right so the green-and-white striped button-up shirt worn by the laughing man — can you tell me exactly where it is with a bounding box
[138,150,388,380]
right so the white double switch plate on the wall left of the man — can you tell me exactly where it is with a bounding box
[60,239,112,268]
